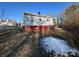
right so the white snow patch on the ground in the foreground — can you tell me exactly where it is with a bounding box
[40,36,78,54]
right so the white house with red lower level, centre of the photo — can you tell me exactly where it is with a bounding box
[23,13,54,31]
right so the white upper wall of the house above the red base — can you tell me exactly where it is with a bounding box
[24,15,53,26]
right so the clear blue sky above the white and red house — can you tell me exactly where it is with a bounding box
[0,2,75,22]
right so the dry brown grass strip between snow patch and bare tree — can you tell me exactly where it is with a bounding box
[51,28,78,47]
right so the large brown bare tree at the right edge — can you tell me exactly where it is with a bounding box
[62,4,79,47]
